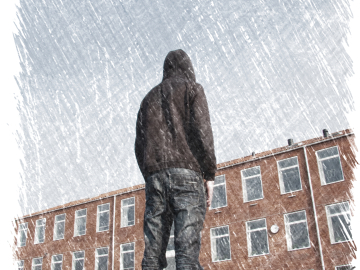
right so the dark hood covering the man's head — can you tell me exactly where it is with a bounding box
[163,49,196,82]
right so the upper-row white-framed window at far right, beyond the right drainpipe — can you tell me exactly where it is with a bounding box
[316,146,344,185]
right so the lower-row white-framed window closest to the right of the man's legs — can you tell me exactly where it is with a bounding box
[210,225,231,262]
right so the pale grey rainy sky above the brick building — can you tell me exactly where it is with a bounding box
[8,0,354,214]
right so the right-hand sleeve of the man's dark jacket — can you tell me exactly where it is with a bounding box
[189,84,216,181]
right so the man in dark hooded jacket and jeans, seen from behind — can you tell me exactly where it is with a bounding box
[135,50,216,270]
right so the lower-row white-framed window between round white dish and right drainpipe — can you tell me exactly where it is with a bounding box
[284,210,310,251]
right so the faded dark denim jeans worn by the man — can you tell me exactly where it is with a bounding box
[142,168,206,270]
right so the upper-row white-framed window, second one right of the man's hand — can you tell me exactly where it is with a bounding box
[241,166,264,202]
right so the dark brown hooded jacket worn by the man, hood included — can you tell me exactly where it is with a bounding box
[135,50,216,180]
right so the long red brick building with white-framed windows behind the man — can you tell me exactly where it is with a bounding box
[15,130,356,270]
